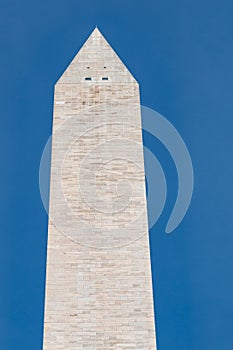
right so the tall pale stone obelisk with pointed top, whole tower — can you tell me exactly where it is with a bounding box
[43,28,156,350]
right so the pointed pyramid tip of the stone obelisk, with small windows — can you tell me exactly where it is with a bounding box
[57,26,135,84]
